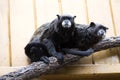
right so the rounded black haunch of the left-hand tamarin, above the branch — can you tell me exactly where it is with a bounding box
[25,42,49,63]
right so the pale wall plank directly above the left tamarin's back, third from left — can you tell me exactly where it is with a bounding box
[36,0,59,27]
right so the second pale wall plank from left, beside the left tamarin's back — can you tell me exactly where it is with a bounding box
[10,0,35,66]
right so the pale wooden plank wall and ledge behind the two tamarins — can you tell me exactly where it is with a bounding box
[0,0,120,79]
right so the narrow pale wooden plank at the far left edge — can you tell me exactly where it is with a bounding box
[0,0,10,66]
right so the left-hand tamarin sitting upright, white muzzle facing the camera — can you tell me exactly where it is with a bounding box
[25,15,75,62]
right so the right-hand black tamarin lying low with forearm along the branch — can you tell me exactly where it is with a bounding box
[63,22,108,56]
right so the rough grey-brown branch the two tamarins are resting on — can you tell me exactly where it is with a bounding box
[0,36,120,80]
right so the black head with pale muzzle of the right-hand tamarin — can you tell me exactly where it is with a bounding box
[88,22,108,38]
